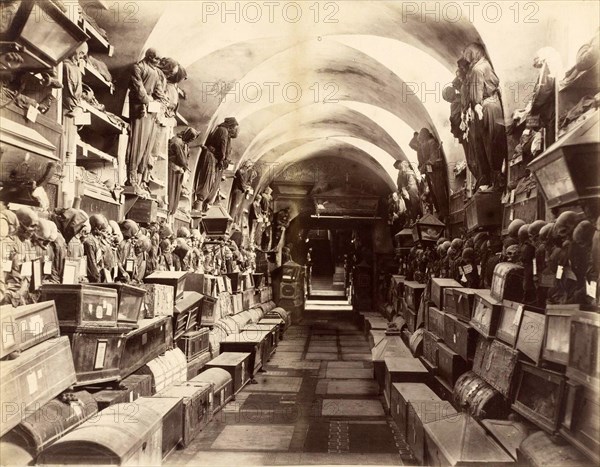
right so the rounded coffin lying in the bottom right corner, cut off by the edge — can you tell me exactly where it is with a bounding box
[517,431,598,467]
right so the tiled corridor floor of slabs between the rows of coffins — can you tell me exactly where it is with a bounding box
[165,312,414,466]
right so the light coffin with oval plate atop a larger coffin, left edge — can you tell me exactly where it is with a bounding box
[0,301,59,358]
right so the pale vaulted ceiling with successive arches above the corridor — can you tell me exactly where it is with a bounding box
[90,0,593,199]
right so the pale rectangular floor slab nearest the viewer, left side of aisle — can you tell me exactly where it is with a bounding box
[211,424,294,451]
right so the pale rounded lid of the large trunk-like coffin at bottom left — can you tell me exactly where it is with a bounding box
[42,399,162,464]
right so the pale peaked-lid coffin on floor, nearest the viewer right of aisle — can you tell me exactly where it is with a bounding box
[424,413,514,466]
